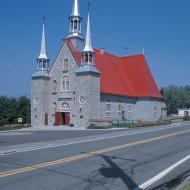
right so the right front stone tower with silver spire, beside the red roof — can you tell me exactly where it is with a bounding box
[76,10,100,127]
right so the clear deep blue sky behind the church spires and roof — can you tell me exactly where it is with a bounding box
[0,0,190,97]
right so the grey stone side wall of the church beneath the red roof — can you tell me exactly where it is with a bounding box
[100,94,165,122]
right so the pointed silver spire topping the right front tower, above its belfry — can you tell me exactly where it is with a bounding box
[83,12,94,52]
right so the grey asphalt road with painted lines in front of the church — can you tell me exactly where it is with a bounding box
[0,125,190,190]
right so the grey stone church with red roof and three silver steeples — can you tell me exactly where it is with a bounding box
[31,0,166,128]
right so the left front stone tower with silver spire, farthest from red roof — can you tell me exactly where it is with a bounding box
[31,18,50,126]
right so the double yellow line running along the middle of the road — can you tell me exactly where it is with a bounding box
[0,129,190,178]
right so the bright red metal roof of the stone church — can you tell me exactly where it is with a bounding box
[67,39,163,99]
